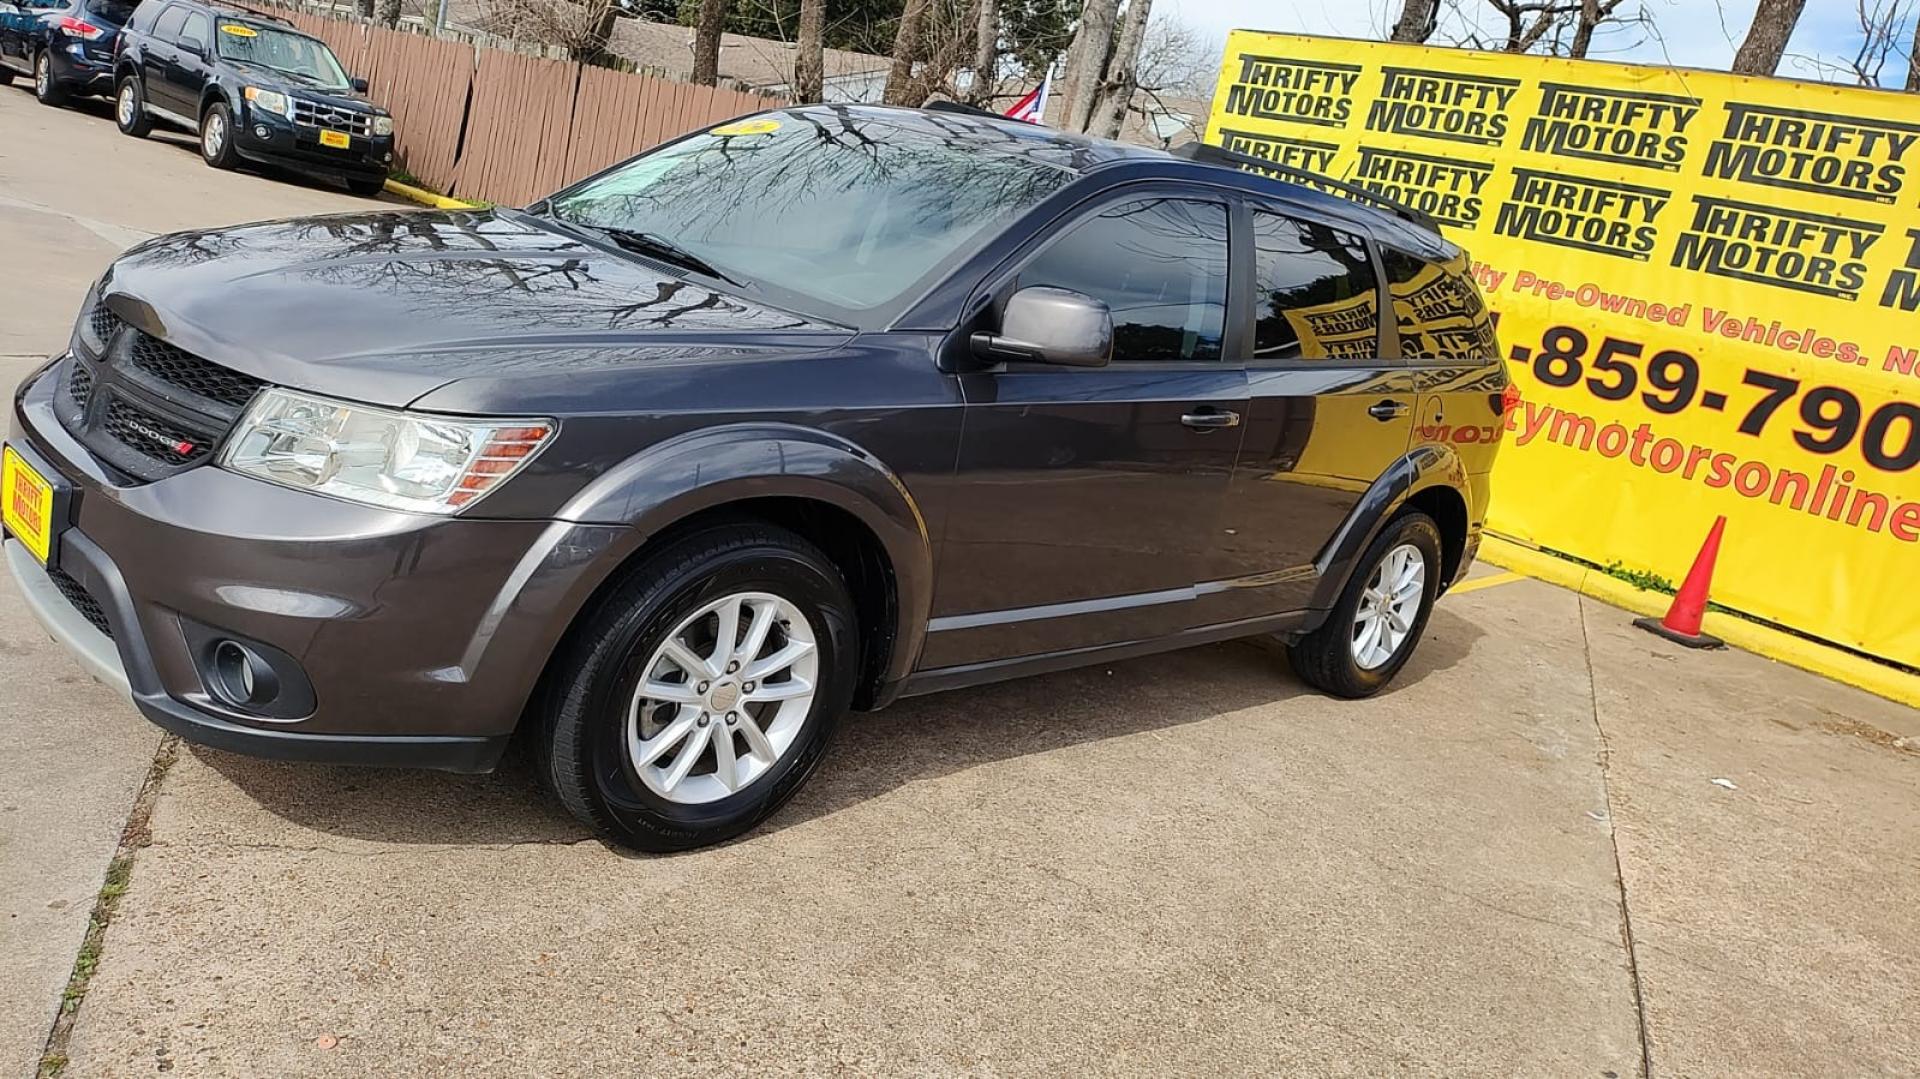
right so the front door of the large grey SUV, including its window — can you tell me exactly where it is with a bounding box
[922,196,1246,668]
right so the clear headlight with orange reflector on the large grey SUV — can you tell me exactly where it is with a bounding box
[221,390,555,513]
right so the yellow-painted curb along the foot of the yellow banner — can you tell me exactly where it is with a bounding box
[1480,536,1920,708]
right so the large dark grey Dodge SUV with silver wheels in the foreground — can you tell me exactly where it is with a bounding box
[0,106,1505,851]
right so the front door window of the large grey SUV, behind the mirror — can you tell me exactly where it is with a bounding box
[1020,198,1227,363]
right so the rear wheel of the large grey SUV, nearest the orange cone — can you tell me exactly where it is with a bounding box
[1286,511,1440,699]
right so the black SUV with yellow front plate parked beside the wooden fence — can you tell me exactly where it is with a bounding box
[113,0,394,196]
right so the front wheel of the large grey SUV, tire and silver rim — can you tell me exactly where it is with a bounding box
[538,522,860,852]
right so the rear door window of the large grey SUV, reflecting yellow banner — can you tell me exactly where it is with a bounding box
[1254,209,1380,359]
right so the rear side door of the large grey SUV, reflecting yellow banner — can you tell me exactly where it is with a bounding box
[1213,202,1421,620]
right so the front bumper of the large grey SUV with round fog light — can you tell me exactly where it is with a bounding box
[6,369,628,772]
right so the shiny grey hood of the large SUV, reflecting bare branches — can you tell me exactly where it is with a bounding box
[100,211,852,405]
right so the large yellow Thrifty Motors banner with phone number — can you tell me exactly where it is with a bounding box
[1208,31,1920,666]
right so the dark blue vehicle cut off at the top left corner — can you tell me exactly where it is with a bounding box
[0,0,136,106]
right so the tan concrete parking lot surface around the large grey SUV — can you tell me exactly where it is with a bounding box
[11,88,1920,1077]
